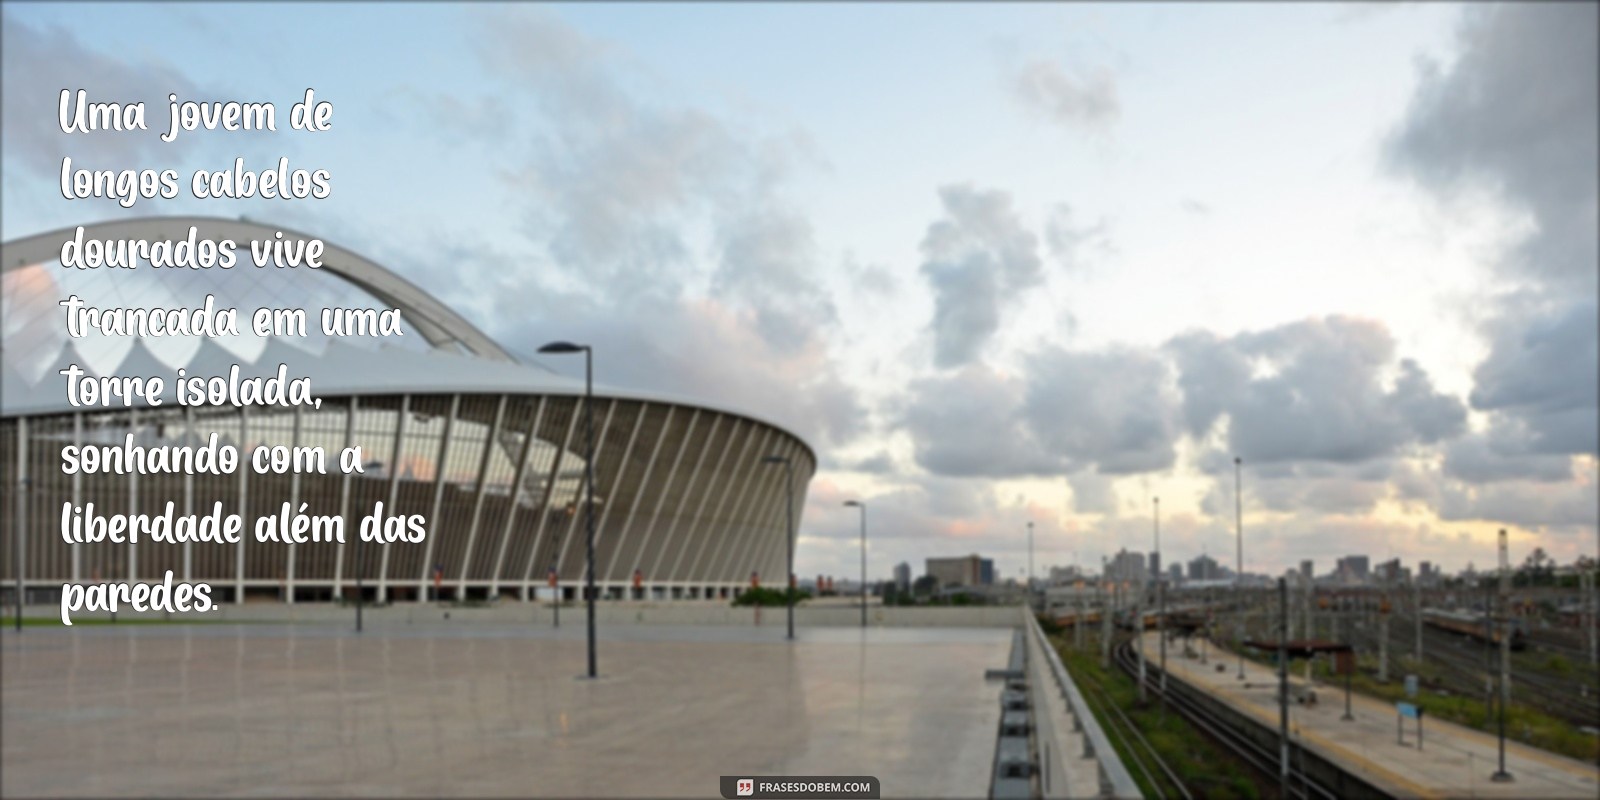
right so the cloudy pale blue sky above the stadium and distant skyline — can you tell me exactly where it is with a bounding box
[0,2,1600,578]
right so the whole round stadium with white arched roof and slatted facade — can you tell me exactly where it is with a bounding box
[0,218,816,602]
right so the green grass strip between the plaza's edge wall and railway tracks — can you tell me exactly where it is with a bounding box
[1054,637,1266,798]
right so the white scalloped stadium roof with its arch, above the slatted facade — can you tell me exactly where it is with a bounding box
[0,216,810,450]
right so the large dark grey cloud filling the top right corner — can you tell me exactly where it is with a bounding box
[1387,3,1600,298]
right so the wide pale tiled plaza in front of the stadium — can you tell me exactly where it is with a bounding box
[0,619,1011,797]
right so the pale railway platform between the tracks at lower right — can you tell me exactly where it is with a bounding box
[1146,634,1600,800]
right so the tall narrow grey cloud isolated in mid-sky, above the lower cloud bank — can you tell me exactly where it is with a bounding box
[922,184,1043,368]
